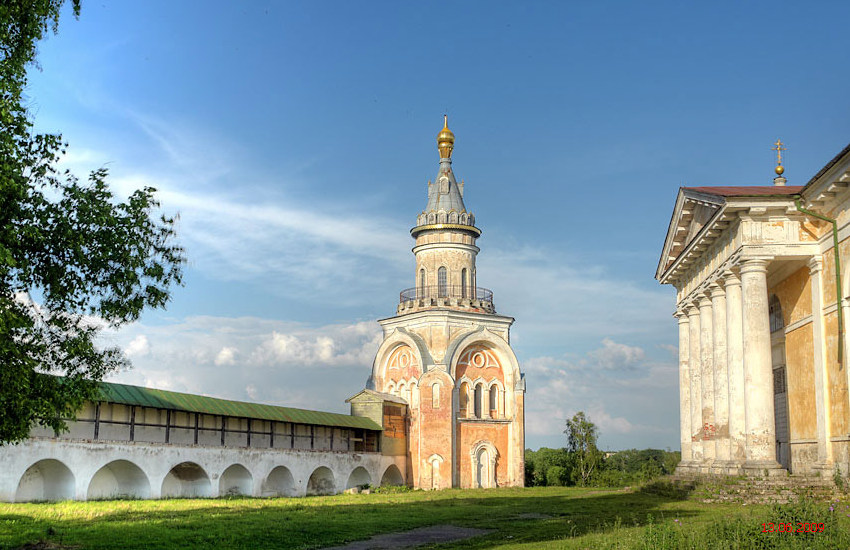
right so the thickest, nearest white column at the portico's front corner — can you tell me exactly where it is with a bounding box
[741,258,780,474]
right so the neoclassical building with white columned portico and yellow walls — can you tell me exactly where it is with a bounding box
[656,141,850,475]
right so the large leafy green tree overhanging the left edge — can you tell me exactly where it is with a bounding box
[0,0,185,444]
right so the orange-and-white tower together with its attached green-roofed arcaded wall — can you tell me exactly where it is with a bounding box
[0,123,525,501]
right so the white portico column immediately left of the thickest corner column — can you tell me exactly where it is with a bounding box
[723,270,747,468]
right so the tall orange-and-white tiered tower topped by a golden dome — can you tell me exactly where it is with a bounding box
[367,117,525,489]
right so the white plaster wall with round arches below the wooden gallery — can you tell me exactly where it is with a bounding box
[0,438,405,501]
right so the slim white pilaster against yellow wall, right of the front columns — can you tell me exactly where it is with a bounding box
[809,256,832,466]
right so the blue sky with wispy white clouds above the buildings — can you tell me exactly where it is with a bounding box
[27,0,850,450]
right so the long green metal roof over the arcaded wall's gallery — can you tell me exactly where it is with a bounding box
[95,382,383,431]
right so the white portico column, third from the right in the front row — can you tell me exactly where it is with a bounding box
[708,283,730,473]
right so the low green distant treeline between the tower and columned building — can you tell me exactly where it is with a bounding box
[525,447,681,487]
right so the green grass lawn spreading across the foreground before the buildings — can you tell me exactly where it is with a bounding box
[0,487,850,549]
